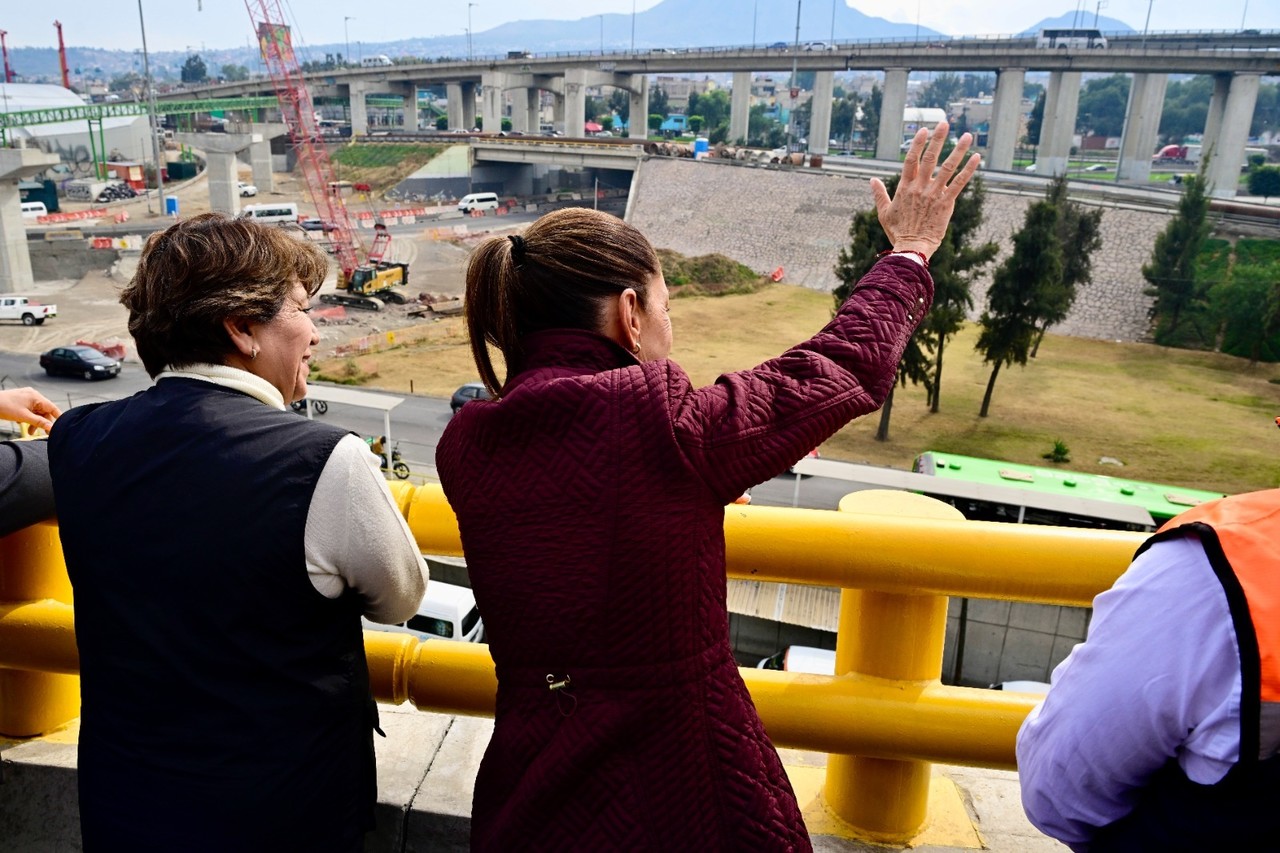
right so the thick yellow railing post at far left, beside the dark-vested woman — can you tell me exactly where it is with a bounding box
[0,523,79,738]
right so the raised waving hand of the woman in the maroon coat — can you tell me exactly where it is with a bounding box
[872,122,980,257]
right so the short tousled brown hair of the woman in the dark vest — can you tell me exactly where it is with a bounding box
[120,214,329,378]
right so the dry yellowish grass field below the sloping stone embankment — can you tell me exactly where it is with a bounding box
[317,284,1280,492]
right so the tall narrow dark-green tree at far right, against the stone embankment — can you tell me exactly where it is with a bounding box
[1142,169,1211,345]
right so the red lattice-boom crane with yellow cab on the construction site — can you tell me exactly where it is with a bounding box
[244,0,408,310]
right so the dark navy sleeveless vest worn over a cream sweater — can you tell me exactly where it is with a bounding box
[49,379,376,850]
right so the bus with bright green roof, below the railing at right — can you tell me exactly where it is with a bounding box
[914,451,1225,530]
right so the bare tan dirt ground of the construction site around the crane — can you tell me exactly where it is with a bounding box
[10,168,508,360]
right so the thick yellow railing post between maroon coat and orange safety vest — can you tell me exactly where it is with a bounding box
[823,489,964,841]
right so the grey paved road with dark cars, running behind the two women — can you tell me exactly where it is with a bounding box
[0,351,858,510]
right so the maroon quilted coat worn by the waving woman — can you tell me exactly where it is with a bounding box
[436,257,933,850]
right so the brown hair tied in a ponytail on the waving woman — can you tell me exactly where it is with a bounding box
[466,207,662,397]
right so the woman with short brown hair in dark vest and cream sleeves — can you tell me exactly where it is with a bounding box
[49,214,426,853]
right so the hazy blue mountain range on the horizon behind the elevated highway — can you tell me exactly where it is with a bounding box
[0,0,1135,82]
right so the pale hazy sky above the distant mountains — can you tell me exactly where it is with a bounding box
[0,0,1280,50]
